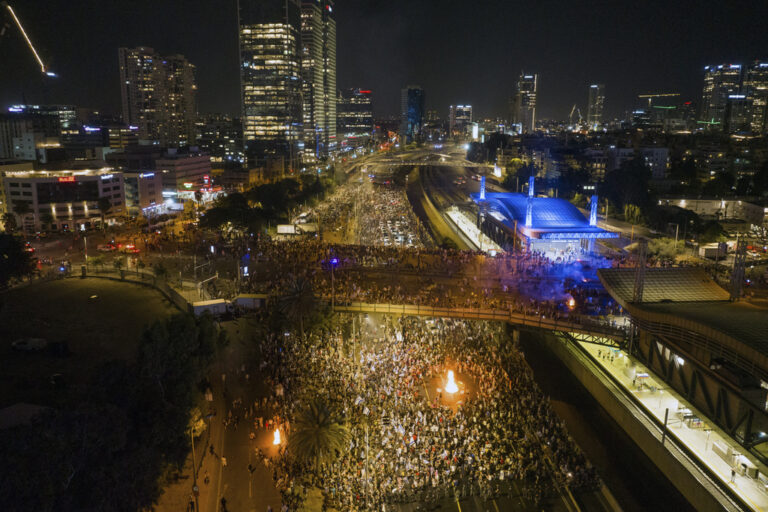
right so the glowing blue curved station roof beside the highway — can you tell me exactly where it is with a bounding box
[470,192,618,239]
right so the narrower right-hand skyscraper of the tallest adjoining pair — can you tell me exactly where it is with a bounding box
[301,0,337,159]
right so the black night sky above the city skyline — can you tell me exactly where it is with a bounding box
[0,0,768,119]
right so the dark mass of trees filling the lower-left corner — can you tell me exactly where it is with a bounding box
[0,314,224,512]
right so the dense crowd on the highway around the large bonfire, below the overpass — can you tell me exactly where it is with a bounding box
[262,319,598,510]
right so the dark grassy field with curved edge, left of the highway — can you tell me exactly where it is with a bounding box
[0,279,178,407]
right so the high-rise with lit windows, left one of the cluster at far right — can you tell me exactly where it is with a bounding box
[699,64,741,132]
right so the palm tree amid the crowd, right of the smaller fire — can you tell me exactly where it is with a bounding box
[288,399,350,473]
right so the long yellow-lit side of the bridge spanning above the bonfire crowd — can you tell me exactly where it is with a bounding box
[333,302,627,345]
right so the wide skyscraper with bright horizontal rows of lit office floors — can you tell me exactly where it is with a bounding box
[238,0,302,168]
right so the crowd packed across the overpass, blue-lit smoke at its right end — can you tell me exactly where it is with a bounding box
[232,240,621,328]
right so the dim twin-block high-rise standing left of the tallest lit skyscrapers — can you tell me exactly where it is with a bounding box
[118,46,197,147]
